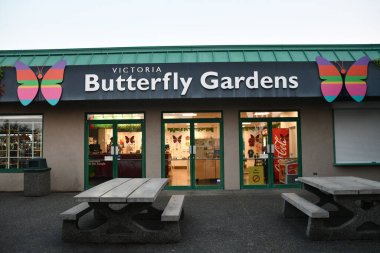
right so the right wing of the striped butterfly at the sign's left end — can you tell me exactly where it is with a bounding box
[41,60,66,106]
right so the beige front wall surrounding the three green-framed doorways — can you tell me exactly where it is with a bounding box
[0,99,380,191]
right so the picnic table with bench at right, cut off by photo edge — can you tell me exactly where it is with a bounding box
[282,177,380,240]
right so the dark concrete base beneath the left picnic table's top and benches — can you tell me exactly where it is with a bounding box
[62,203,181,243]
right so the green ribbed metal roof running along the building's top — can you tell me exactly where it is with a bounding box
[0,44,380,66]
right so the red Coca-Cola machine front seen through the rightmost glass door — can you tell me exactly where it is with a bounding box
[272,128,289,183]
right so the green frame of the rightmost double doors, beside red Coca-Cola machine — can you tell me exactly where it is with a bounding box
[239,113,302,189]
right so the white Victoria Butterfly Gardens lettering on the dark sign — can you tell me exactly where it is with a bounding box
[85,66,298,96]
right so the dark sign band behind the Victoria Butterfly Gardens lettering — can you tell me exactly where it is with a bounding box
[0,62,380,102]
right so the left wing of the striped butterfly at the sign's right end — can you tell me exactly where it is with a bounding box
[315,56,343,103]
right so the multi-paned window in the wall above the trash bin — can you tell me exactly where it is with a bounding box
[0,115,42,169]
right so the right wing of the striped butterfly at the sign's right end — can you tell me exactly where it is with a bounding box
[344,56,370,102]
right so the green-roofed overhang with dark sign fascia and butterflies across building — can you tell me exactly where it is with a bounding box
[0,45,380,105]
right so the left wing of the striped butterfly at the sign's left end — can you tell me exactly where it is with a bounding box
[15,61,38,106]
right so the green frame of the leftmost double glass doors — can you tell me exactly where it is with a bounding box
[84,115,146,189]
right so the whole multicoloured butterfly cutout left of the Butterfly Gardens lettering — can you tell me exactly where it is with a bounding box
[15,60,66,106]
